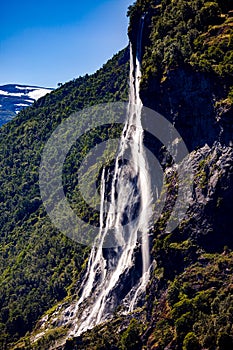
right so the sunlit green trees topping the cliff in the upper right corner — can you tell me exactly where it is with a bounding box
[128,0,233,102]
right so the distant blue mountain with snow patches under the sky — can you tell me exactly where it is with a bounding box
[0,84,53,126]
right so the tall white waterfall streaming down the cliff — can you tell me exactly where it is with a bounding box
[72,16,152,336]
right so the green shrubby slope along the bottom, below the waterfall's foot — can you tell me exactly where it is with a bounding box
[36,251,233,350]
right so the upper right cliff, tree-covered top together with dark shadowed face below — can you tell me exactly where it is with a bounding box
[129,0,233,151]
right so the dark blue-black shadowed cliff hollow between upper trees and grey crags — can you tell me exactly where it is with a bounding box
[142,66,233,151]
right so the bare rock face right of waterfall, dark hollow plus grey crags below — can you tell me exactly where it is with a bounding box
[139,61,233,251]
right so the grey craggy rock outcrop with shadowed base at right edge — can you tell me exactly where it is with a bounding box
[187,143,233,252]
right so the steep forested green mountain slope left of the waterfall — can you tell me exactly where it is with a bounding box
[0,49,129,349]
